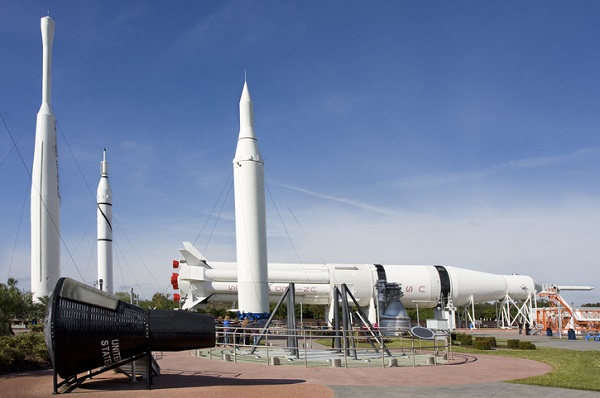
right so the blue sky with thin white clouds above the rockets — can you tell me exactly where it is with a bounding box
[0,0,600,303]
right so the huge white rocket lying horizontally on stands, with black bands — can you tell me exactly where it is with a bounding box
[172,242,541,309]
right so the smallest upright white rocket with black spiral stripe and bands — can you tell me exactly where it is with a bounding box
[96,149,113,293]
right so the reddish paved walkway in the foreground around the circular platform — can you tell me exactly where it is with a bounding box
[0,333,600,398]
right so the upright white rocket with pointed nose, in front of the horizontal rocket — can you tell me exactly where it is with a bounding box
[233,82,269,315]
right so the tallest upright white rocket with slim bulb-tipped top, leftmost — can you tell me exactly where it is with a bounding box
[31,17,60,301]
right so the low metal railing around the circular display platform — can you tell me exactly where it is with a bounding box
[194,326,452,368]
